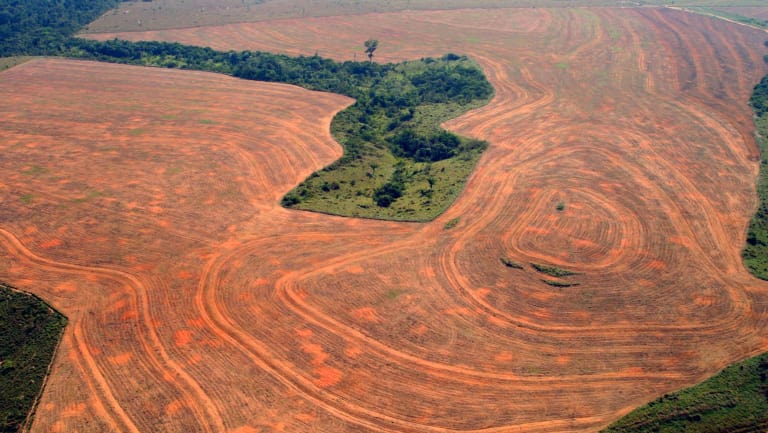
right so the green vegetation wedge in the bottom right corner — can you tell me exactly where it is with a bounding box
[603,354,768,433]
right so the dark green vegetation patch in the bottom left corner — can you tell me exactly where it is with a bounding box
[0,284,66,433]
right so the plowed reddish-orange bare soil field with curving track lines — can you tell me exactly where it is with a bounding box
[0,8,768,433]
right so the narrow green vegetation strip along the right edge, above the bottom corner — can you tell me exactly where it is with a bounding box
[742,66,768,280]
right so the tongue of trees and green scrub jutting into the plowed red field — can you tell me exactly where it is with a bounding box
[64,39,493,221]
